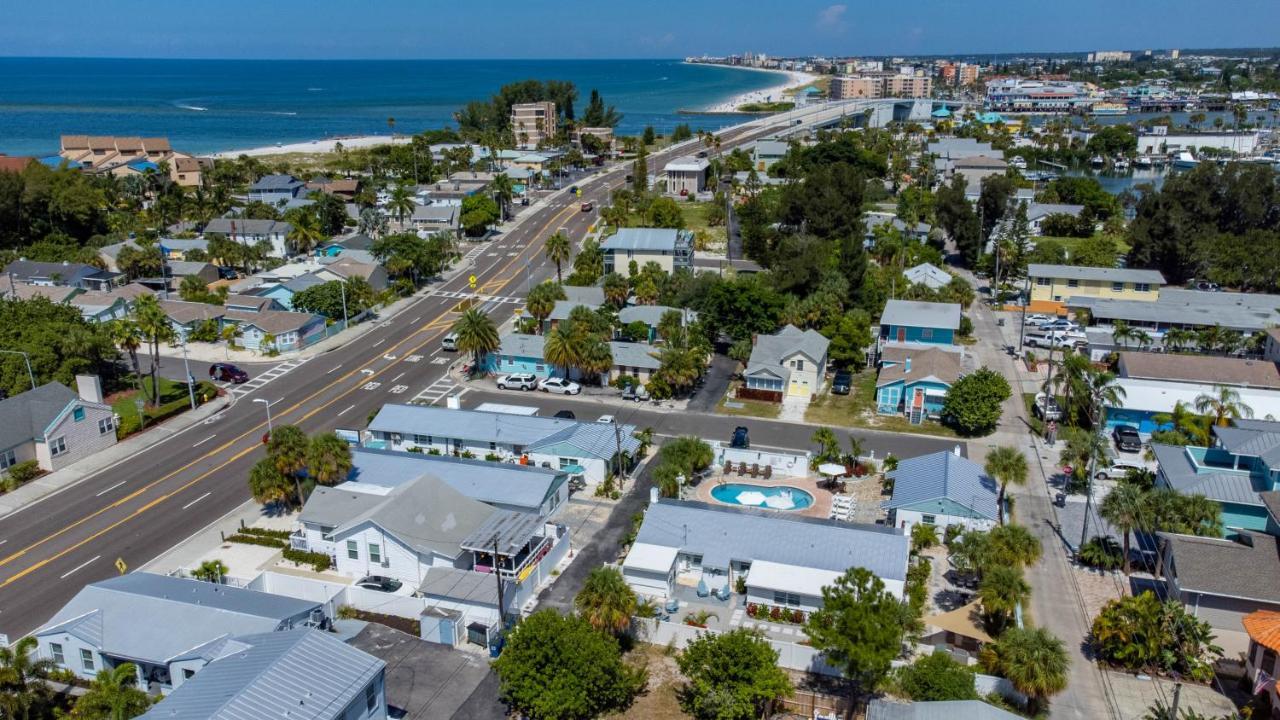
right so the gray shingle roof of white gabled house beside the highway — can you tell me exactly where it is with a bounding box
[298,474,495,557]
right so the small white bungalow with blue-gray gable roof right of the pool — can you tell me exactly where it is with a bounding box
[882,450,1000,534]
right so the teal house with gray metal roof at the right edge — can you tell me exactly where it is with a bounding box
[1151,419,1280,532]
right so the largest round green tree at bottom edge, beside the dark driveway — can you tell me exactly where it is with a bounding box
[493,610,646,720]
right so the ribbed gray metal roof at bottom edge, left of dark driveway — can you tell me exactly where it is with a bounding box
[142,628,387,720]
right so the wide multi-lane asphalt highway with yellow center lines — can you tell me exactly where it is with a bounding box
[0,99,870,638]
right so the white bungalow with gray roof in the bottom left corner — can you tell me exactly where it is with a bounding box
[33,573,328,693]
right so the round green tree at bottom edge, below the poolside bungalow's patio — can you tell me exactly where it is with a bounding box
[676,628,794,720]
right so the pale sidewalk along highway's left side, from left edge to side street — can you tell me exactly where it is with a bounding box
[0,393,236,519]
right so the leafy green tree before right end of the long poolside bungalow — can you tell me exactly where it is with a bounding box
[804,568,908,692]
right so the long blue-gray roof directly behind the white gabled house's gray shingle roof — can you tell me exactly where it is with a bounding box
[347,447,568,511]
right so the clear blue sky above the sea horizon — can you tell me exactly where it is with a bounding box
[0,0,1280,58]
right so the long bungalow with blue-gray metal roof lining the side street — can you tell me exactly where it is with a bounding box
[364,405,640,486]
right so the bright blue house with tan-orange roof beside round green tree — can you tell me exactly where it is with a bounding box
[876,346,960,425]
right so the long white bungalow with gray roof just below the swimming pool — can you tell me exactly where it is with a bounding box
[622,500,910,612]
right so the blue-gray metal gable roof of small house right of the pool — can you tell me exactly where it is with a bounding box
[884,450,998,520]
